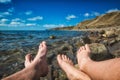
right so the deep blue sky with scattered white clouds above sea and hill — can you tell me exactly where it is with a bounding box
[0,0,120,30]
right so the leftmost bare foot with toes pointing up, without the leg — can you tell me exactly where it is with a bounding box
[25,41,48,77]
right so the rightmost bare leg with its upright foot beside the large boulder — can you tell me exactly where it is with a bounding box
[77,45,120,80]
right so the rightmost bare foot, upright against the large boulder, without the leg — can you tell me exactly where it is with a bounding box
[77,44,91,70]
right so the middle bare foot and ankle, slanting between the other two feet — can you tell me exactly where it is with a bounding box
[57,55,90,80]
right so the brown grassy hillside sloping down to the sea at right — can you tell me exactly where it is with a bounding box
[54,11,120,30]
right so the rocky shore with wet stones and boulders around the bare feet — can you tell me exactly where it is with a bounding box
[0,28,120,80]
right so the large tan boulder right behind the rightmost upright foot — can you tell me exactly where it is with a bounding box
[89,43,113,61]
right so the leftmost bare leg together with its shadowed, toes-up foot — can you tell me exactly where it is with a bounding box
[3,42,48,80]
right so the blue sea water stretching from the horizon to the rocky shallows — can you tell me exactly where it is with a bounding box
[0,30,85,51]
